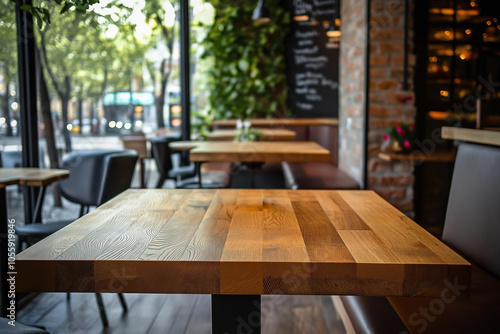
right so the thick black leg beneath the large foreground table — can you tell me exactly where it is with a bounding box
[212,295,261,334]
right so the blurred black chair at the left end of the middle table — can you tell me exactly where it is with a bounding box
[150,137,196,188]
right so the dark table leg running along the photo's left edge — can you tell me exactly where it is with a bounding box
[0,188,9,317]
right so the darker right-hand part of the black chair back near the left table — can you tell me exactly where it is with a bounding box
[98,150,138,205]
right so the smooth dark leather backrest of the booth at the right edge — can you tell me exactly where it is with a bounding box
[443,143,500,277]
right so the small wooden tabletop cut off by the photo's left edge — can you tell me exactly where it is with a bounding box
[0,168,69,188]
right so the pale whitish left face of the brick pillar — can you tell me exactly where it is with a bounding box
[339,0,367,183]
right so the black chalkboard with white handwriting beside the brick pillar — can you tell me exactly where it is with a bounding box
[287,0,339,118]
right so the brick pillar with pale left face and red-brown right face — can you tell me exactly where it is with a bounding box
[339,0,416,216]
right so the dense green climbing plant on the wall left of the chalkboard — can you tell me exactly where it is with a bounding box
[203,0,290,119]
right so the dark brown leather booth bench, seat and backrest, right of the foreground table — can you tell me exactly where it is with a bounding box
[333,143,500,334]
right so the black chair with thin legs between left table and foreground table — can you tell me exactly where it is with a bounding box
[16,150,137,326]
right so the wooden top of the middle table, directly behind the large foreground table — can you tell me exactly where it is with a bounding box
[184,141,330,162]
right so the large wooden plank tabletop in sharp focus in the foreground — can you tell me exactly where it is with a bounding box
[16,189,470,296]
